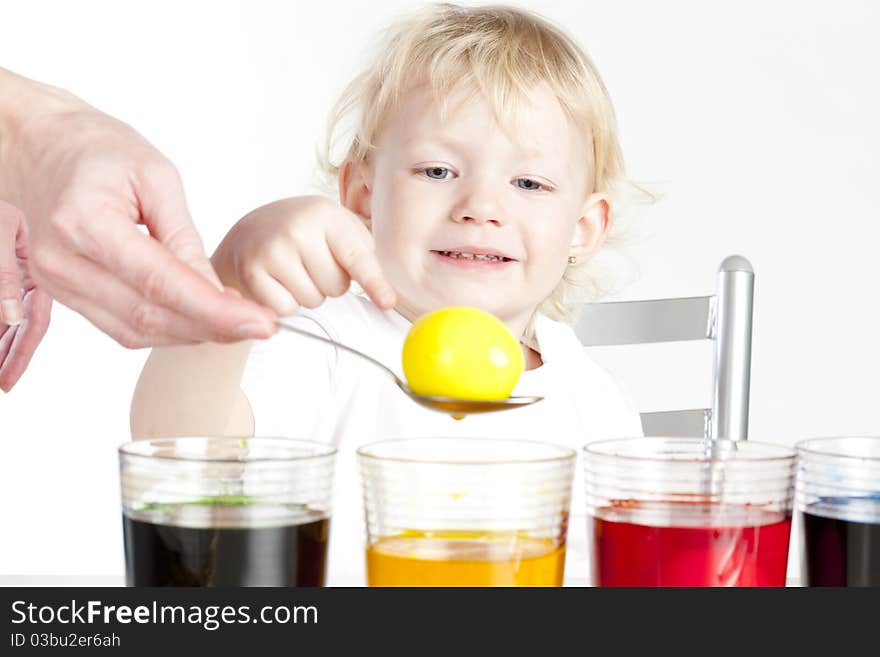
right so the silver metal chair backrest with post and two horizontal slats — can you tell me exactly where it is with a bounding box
[575,255,755,440]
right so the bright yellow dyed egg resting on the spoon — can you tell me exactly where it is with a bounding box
[403,306,523,400]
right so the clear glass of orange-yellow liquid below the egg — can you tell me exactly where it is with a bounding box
[358,438,576,586]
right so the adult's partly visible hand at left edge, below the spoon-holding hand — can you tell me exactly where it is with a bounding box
[0,201,52,392]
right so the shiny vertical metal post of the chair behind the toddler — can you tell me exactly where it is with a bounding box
[710,255,755,440]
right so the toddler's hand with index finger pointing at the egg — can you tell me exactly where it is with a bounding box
[211,196,396,316]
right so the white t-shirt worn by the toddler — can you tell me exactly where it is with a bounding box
[241,292,642,586]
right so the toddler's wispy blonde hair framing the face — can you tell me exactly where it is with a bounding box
[319,4,644,326]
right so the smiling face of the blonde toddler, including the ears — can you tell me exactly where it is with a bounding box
[343,80,608,331]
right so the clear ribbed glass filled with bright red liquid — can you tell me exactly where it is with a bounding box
[584,437,796,586]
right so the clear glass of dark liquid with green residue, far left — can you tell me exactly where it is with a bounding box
[119,438,335,586]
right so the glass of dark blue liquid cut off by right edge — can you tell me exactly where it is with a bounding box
[795,437,880,586]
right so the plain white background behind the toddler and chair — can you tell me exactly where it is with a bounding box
[0,0,880,575]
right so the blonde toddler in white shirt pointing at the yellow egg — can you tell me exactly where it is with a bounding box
[131,0,641,586]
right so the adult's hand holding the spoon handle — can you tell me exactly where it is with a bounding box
[0,70,276,348]
